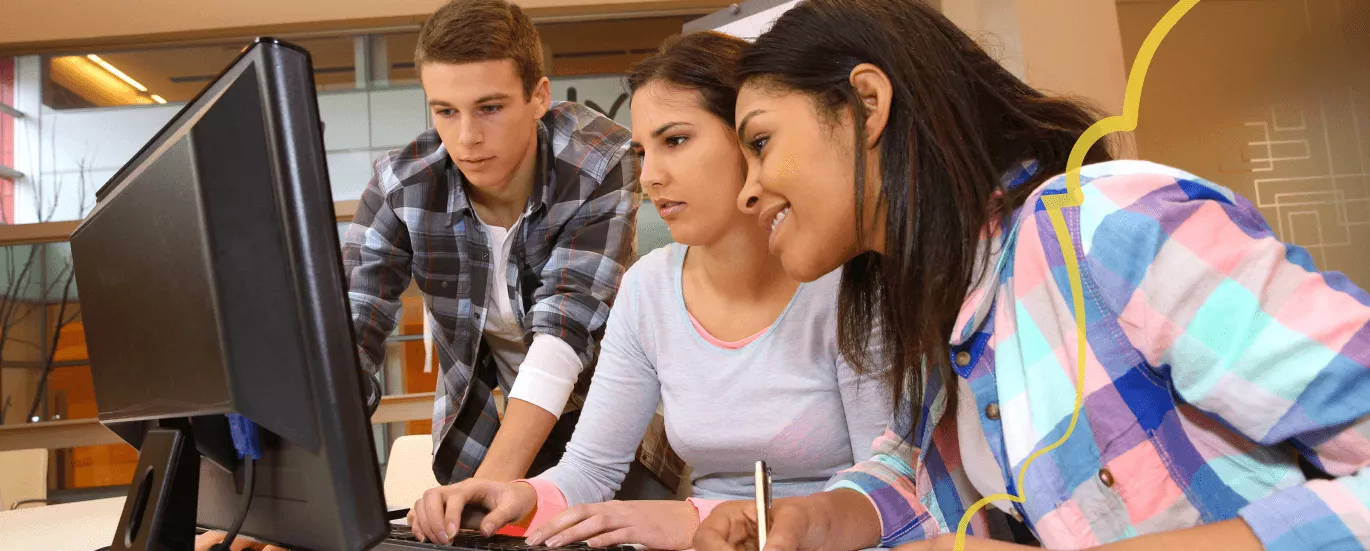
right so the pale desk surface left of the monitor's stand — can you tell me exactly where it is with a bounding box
[0,498,123,551]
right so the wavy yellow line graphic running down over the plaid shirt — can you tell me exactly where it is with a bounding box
[955,0,1200,551]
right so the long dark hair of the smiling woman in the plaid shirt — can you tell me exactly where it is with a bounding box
[738,0,1110,425]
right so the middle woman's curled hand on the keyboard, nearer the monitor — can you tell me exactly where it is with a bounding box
[408,478,537,544]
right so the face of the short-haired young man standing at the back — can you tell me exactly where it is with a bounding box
[419,59,551,189]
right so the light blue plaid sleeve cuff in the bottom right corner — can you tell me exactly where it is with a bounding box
[1237,478,1370,551]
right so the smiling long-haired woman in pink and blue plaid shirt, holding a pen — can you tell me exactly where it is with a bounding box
[695,0,1370,551]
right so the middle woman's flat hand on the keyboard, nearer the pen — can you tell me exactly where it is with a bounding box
[527,500,699,550]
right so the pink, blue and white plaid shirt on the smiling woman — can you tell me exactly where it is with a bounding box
[830,160,1370,550]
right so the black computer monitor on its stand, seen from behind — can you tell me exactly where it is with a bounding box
[71,38,388,550]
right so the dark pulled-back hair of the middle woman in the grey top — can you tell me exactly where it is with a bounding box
[627,30,748,127]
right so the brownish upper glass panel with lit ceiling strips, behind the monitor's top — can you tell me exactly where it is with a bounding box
[44,37,356,110]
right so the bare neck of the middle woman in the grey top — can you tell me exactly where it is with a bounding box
[688,218,797,300]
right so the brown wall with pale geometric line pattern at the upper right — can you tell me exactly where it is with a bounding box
[1118,0,1370,286]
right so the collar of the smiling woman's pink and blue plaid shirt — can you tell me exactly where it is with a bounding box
[951,160,1037,345]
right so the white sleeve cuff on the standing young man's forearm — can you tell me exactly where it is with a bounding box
[508,333,584,417]
